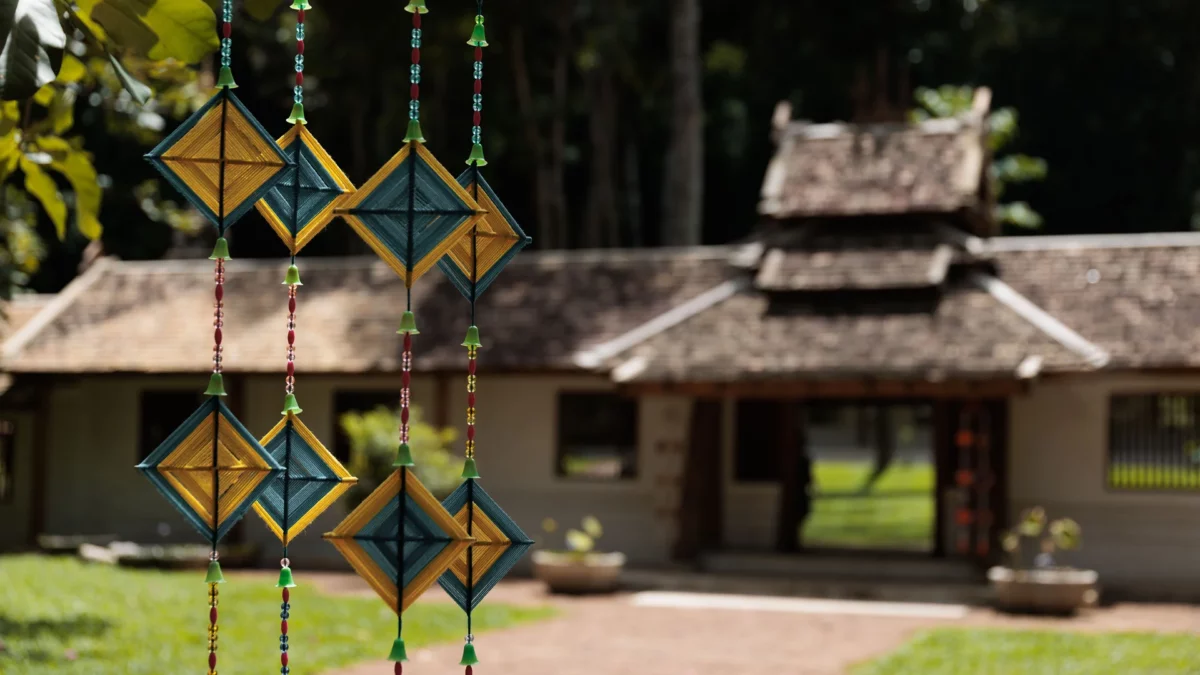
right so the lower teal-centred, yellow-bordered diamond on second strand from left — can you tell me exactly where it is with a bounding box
[254,413,358,542]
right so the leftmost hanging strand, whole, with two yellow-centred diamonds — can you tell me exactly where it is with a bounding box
[137,0,292,675]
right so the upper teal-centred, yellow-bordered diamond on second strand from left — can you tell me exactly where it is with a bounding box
[249,124,354,253]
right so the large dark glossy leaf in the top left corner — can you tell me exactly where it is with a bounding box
[0,0,67,101]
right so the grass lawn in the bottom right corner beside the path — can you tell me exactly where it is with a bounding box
[852,628,1200,675]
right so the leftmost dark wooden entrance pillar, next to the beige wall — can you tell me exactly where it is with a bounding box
[672,399,725,561]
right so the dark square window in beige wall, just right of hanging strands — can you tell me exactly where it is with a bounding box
[557,394,637,480]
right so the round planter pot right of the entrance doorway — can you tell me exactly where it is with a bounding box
[988,567,1099,614]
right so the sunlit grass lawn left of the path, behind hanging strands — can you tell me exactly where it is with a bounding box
[0,556,553,675]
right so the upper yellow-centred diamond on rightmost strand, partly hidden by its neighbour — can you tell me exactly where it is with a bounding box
[438,168,532,300]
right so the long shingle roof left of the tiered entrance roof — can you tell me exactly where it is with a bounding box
[4,247,727,372]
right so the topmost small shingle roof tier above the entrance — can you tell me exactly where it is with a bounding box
[758,117,988,219]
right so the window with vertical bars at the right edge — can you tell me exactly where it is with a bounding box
[1108,394,1200,490]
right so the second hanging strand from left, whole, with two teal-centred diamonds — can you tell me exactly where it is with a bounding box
[254,5,358,675]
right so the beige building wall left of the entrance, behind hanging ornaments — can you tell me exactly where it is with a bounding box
[37,371,690,567]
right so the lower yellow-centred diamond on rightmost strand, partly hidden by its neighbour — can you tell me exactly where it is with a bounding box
[438,480,533,611]
